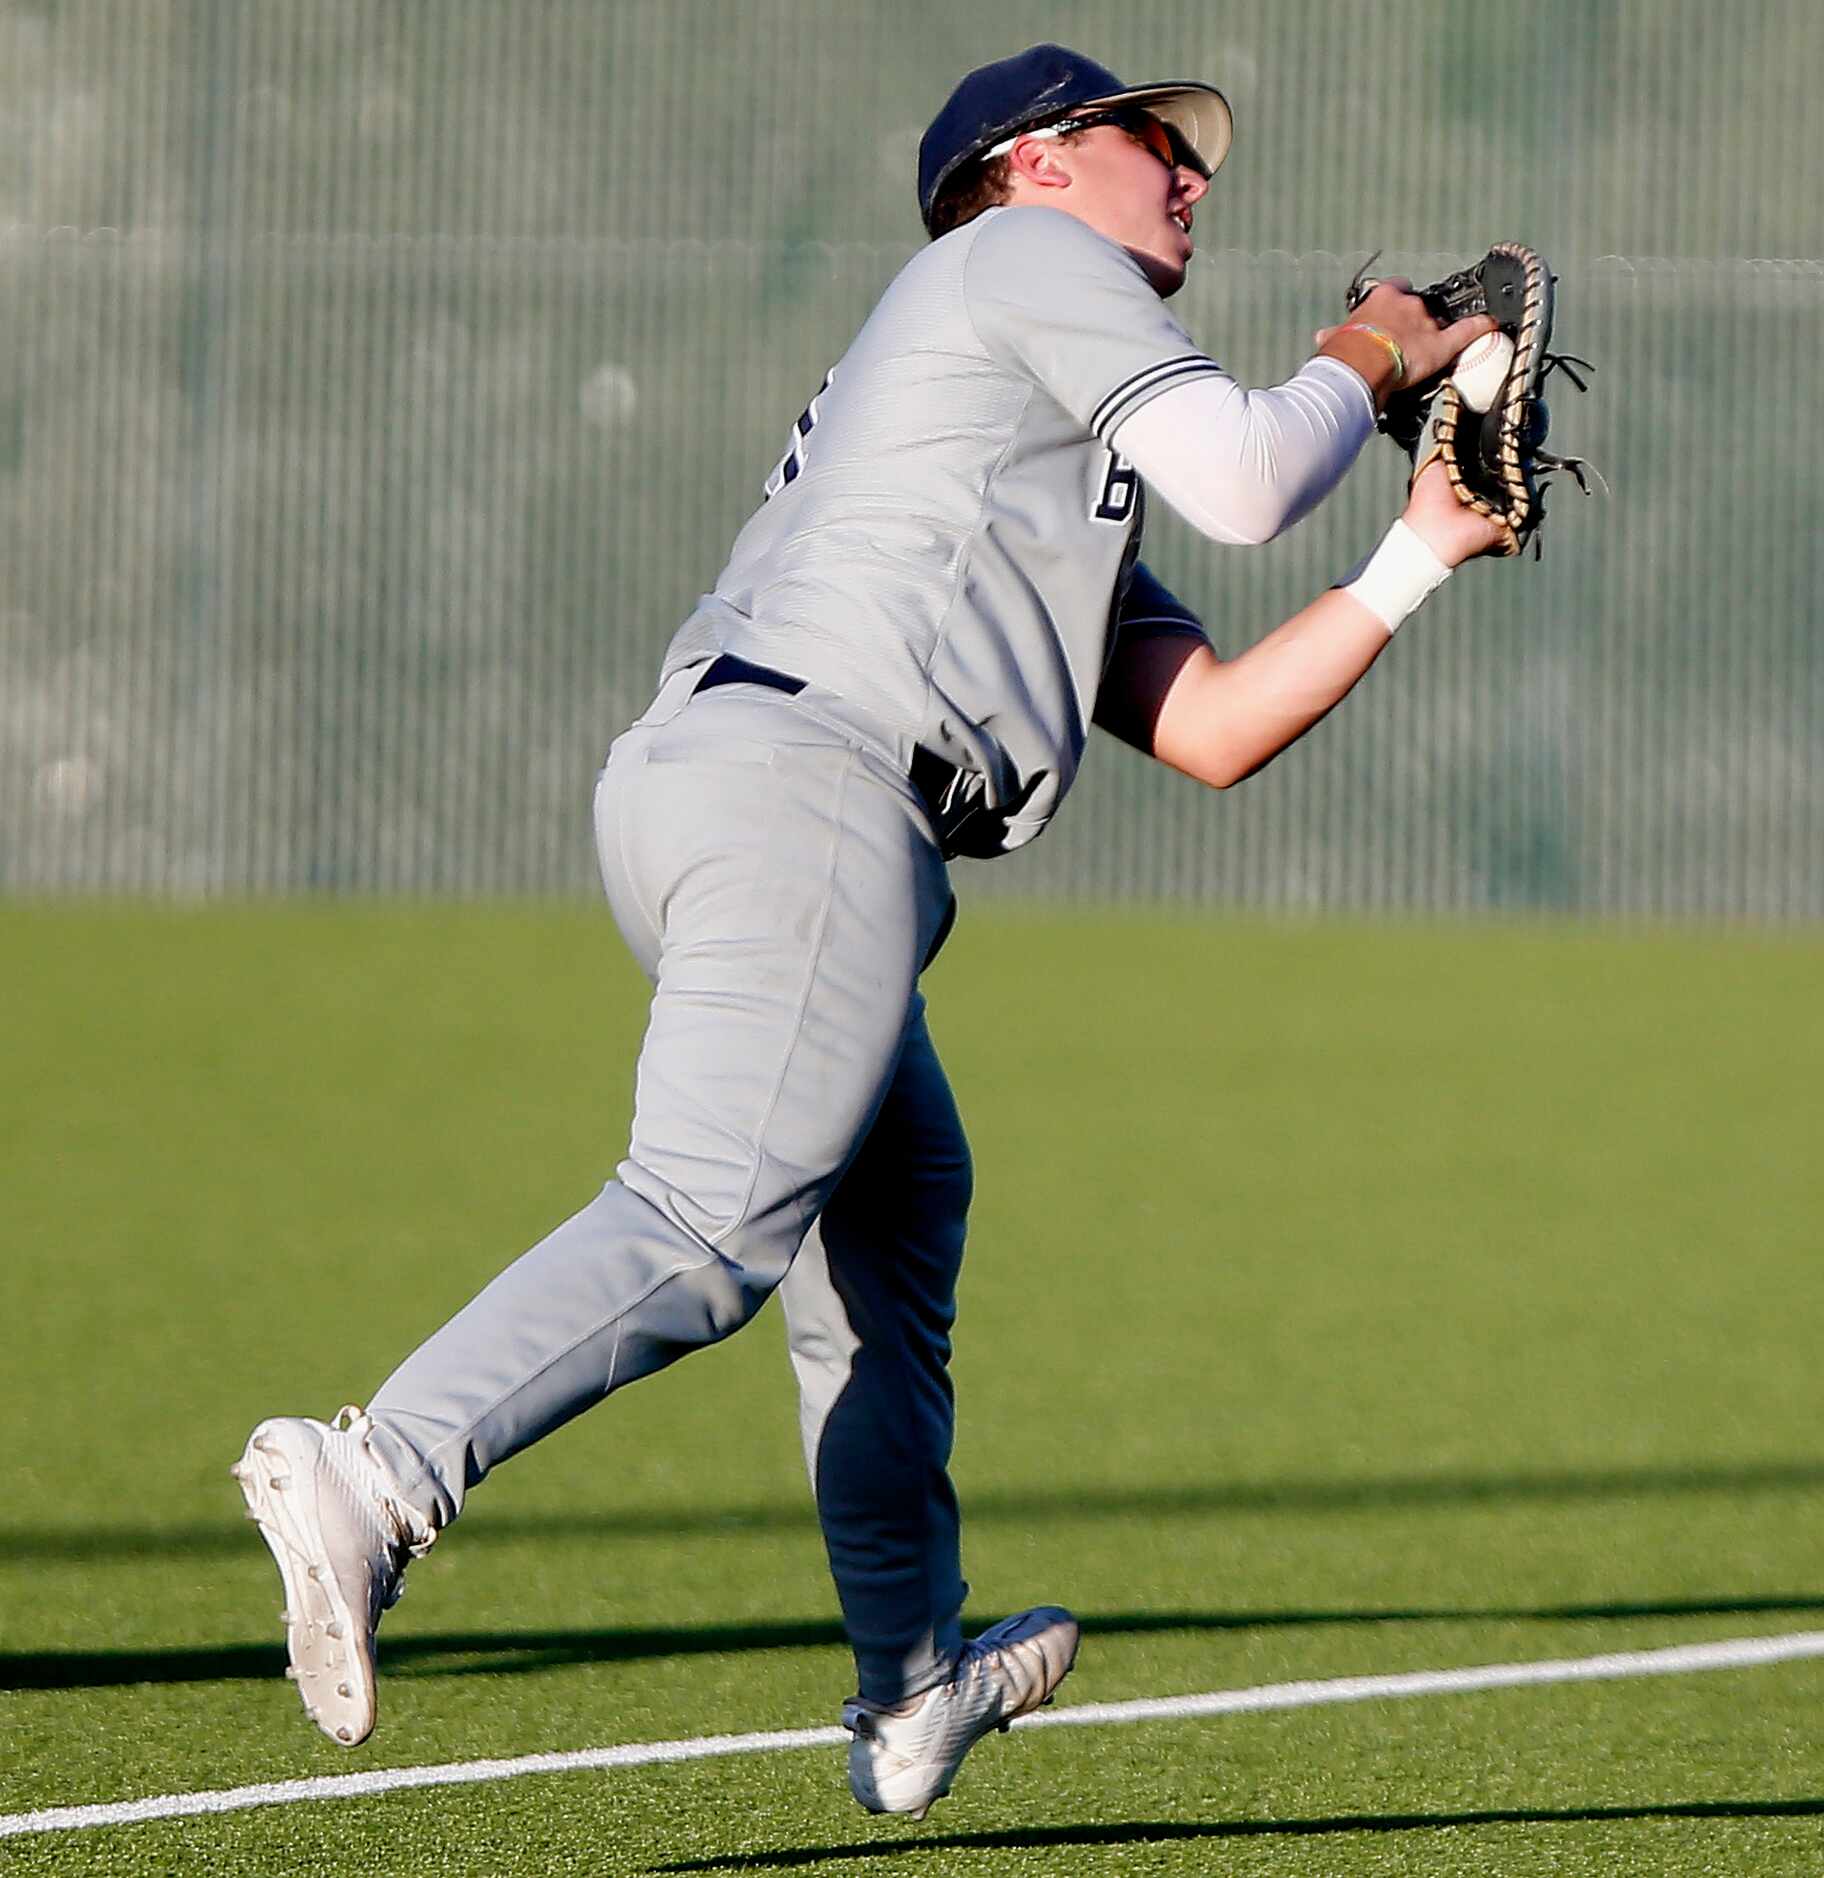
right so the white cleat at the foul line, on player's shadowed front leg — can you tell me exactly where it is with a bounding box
[842,1604,1078,1820]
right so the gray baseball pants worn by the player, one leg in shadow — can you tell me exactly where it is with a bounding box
[368,674,969,1701]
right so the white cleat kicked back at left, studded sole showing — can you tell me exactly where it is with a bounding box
[229,1409,438,1748]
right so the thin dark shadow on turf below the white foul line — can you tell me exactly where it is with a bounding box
[646,1799,1824,1872]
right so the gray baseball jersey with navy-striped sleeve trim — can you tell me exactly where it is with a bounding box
[665,207,1221,851]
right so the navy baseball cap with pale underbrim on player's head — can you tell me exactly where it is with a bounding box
[919,45,1234,229]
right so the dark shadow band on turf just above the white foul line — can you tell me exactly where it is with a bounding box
[0,1596,1824,1690]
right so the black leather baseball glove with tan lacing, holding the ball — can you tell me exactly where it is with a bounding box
[1349,242,1595,554]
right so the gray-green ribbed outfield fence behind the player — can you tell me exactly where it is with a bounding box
[0,0,1824,918]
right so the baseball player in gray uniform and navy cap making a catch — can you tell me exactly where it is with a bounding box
[235,45,1493,1818]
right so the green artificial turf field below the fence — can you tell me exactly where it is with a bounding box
[0,905,1824,1878]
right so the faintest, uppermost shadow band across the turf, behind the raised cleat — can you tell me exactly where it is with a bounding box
[0,1461,1824,1564]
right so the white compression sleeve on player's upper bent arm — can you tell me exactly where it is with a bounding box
[1110,359,1375,543]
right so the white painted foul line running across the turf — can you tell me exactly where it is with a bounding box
[0,1630,1824,1839]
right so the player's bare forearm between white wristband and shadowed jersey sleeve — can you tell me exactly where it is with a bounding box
[1153,588,1390,789]
